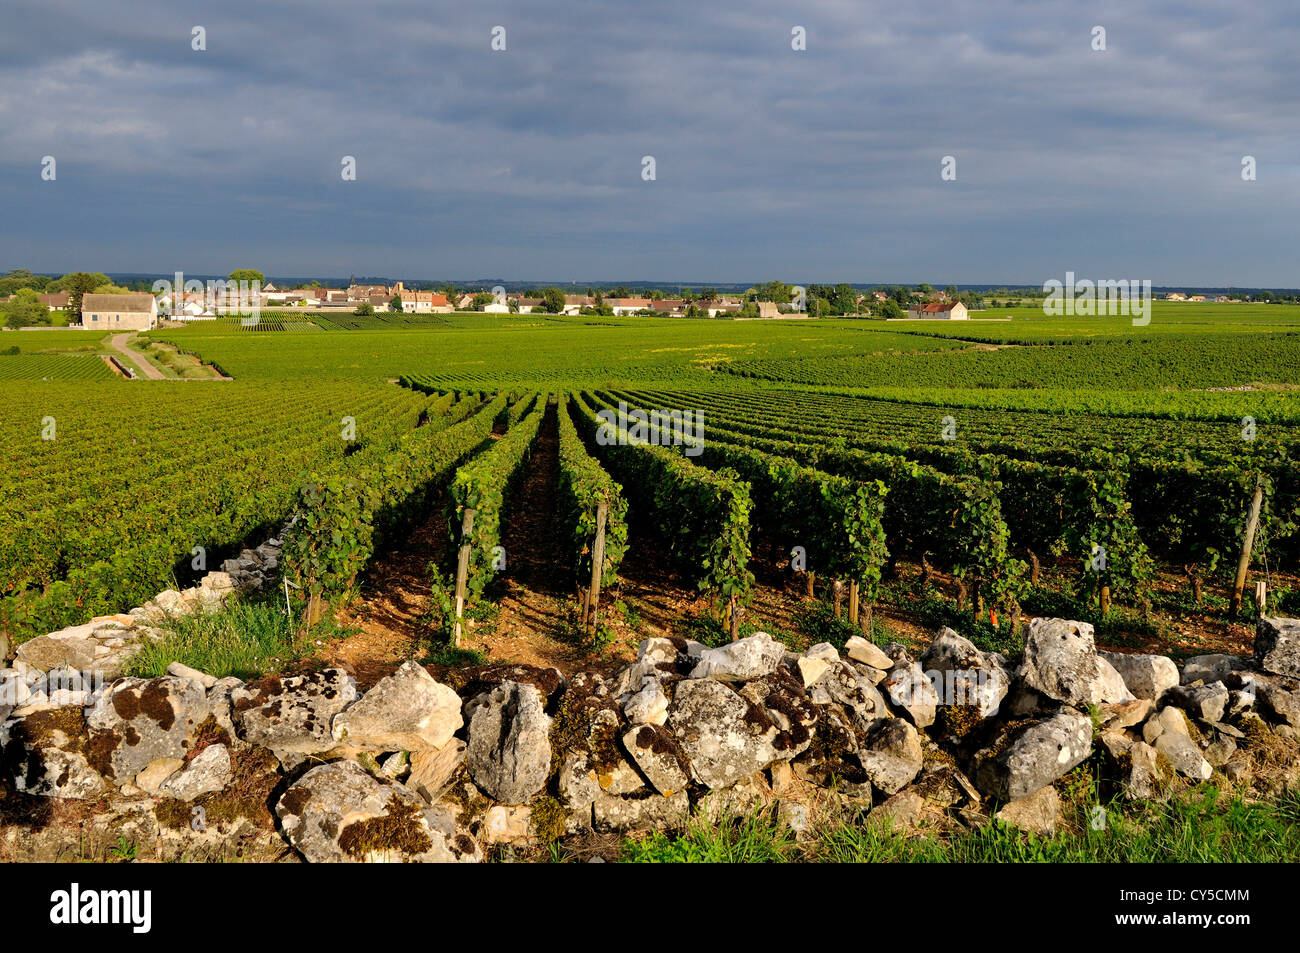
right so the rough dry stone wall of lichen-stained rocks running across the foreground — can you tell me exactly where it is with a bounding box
[0,619,1300,862]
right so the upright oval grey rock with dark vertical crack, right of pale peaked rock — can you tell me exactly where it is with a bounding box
[465,681,551,805]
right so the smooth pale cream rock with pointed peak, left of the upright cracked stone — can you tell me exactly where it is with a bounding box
[333,662,464,751]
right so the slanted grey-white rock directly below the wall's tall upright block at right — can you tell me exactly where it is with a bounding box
[974,709,1092,802]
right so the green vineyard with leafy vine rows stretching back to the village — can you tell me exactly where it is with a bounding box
[0,306,1300,657]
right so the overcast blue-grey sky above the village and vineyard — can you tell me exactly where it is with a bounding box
[0,0,1300,287]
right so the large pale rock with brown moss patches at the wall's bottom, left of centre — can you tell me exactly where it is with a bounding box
[276,761,482,863]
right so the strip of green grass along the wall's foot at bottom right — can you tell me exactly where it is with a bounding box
[623,784,1300,863]
